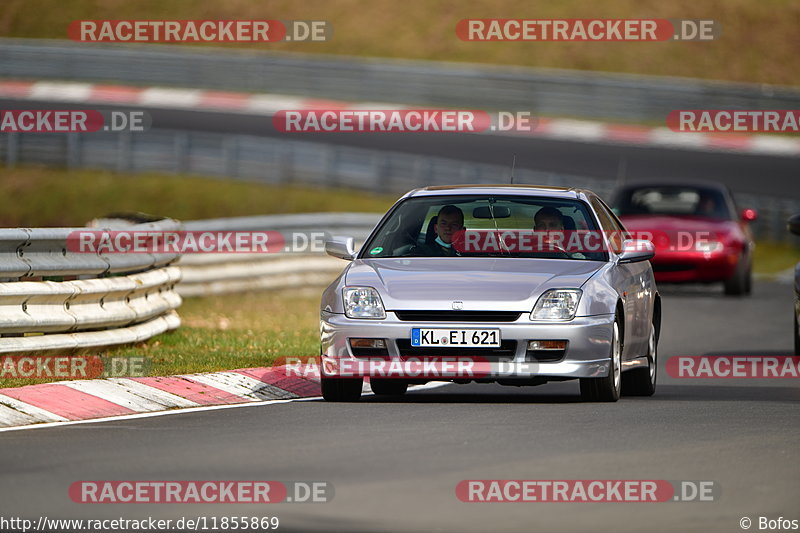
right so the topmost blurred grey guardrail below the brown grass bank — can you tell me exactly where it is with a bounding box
[0,39,800,122]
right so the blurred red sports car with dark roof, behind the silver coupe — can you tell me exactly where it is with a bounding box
[612,183,756,295]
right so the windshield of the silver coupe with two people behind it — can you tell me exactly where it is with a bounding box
[359,195,608,261]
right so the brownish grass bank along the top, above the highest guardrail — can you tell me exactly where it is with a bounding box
[0,0,800,88]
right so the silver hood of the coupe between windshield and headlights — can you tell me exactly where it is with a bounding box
[345,257,605,311]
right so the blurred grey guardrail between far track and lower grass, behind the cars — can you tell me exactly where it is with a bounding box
[0,130,800,244]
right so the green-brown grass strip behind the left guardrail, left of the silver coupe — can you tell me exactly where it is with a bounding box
[0,166,396,227]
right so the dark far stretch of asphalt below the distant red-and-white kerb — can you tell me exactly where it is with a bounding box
[0,99,800,199]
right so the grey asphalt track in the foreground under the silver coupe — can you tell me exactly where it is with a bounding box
[0,282,800,532]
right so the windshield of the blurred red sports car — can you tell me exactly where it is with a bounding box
[614,186,730,219]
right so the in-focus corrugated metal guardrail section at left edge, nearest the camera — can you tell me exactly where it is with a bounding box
[0,219,181,353]
